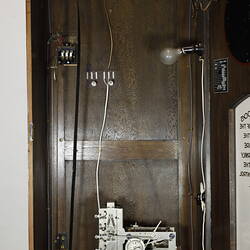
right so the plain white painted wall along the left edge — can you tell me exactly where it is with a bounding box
[0,0,28,250]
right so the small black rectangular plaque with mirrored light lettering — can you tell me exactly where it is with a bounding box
[213,58,228,93]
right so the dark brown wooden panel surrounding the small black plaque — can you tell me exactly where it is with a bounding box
[211,0,250,250]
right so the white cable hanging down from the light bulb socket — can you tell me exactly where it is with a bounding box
[200,58,206,250]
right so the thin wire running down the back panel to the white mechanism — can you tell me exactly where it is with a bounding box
[95,0,114,211]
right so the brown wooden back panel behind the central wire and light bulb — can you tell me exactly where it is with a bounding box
[47,0,204,249]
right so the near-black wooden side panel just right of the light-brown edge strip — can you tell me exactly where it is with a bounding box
[30,0,50,250]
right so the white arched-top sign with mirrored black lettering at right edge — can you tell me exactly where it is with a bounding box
[235,97,250,250]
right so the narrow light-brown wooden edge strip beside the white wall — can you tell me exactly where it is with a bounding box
[26,0,34,250]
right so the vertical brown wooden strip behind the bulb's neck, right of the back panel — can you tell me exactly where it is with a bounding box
[177,0,191,250]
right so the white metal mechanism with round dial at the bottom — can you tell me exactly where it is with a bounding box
[95,202,177,250]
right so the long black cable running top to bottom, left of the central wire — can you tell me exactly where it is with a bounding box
[69,1,81,250]
